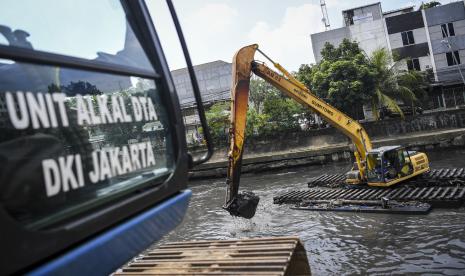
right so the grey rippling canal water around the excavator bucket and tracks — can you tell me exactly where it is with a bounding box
[160,149,465,275]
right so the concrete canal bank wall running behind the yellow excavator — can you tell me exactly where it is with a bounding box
[190,128,465,179]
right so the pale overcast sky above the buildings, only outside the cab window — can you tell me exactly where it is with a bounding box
[147,0,451,71]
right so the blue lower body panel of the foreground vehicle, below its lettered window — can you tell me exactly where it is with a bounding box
[28,190,192,276]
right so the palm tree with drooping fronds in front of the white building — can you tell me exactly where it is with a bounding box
[369,48,424,120]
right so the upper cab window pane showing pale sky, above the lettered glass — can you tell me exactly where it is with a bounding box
[0,0,153,71]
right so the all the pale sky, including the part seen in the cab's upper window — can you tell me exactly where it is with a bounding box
[0,0,453,71]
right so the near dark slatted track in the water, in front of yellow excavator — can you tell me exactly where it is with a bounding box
[273,186,465,208]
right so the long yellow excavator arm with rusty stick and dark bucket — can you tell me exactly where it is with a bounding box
[223,44,372,218]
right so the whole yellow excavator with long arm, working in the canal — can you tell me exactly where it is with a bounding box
[223,44,429,218]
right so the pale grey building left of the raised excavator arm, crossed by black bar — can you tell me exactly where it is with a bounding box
[171,60,232,142]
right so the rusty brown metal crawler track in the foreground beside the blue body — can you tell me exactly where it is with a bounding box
[114,237,311,275]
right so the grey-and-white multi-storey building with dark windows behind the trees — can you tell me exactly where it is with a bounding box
[311,1,465,113]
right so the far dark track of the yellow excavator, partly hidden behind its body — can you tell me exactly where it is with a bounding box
[308,168,465,188]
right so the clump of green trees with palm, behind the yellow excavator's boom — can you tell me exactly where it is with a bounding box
[296,39,427,119]
